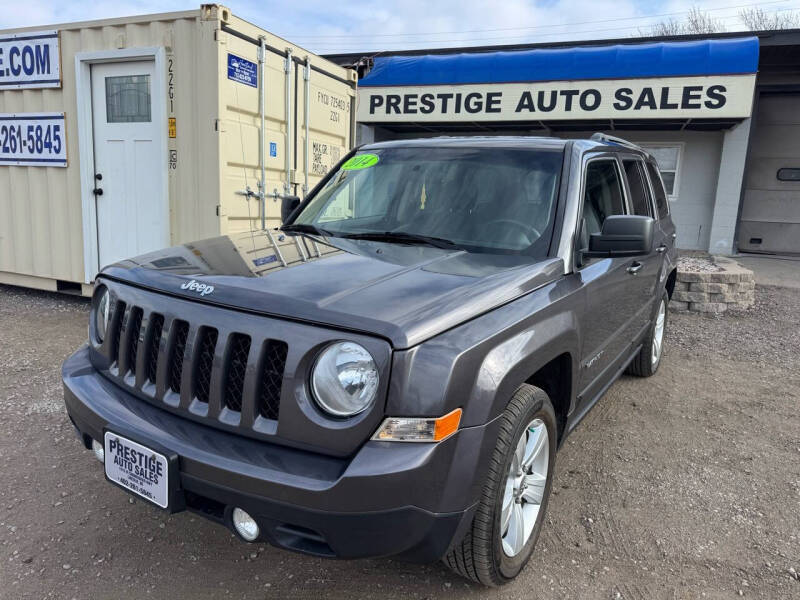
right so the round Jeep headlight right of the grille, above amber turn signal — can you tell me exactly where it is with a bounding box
[311,342,379,417]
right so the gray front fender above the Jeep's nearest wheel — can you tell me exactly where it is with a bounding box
[386,278,581,428]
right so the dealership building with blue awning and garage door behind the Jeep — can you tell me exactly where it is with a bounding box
[326,31,800,254]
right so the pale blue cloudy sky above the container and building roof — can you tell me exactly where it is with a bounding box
[0,0,800,53]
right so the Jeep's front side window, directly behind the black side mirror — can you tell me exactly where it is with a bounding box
[581,159,625,250]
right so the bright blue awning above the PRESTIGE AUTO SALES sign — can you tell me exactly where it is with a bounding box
[358,37,758,87]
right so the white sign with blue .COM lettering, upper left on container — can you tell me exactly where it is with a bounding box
[0,31,61,91]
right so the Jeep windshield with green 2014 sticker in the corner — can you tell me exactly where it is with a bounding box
[285,146,563,256]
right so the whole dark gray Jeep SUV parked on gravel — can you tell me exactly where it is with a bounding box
[63,135,676,585]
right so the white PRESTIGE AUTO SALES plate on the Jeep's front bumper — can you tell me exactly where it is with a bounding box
[105,431,169,508]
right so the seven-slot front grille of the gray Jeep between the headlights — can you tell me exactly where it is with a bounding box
[108,301,288,432]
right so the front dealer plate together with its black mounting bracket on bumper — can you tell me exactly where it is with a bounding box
[103,429,185,513]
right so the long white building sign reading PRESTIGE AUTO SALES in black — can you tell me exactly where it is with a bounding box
[356,75,755,123]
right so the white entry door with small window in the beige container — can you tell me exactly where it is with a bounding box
[91,61,169,268]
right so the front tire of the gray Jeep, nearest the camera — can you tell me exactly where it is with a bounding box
[443,384,557,587]
